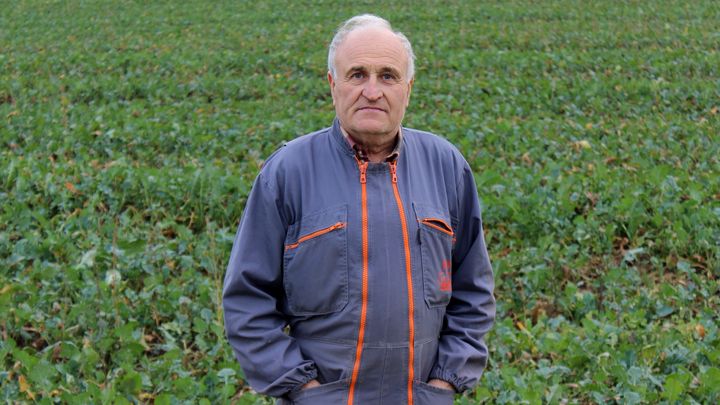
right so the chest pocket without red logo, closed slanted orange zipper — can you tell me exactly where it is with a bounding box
[283,205,348,315]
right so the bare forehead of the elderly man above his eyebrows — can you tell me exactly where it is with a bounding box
[335,27,407,74]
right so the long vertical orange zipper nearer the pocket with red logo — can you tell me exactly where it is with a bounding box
[390,159,415,405]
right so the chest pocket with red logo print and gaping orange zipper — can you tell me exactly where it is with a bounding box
[413,203,455,308]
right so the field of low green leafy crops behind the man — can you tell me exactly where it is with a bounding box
[0,0,720,404]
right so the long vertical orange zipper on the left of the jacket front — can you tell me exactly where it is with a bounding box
[347,156,369,405]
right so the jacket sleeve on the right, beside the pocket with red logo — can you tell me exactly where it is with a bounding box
[430,159,495,392]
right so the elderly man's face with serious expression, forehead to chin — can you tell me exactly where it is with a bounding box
[328,28,412,143]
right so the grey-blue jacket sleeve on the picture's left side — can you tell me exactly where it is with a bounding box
[223,172,317,397]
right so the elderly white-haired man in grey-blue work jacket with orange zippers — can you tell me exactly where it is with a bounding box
[223,15,495,405]
